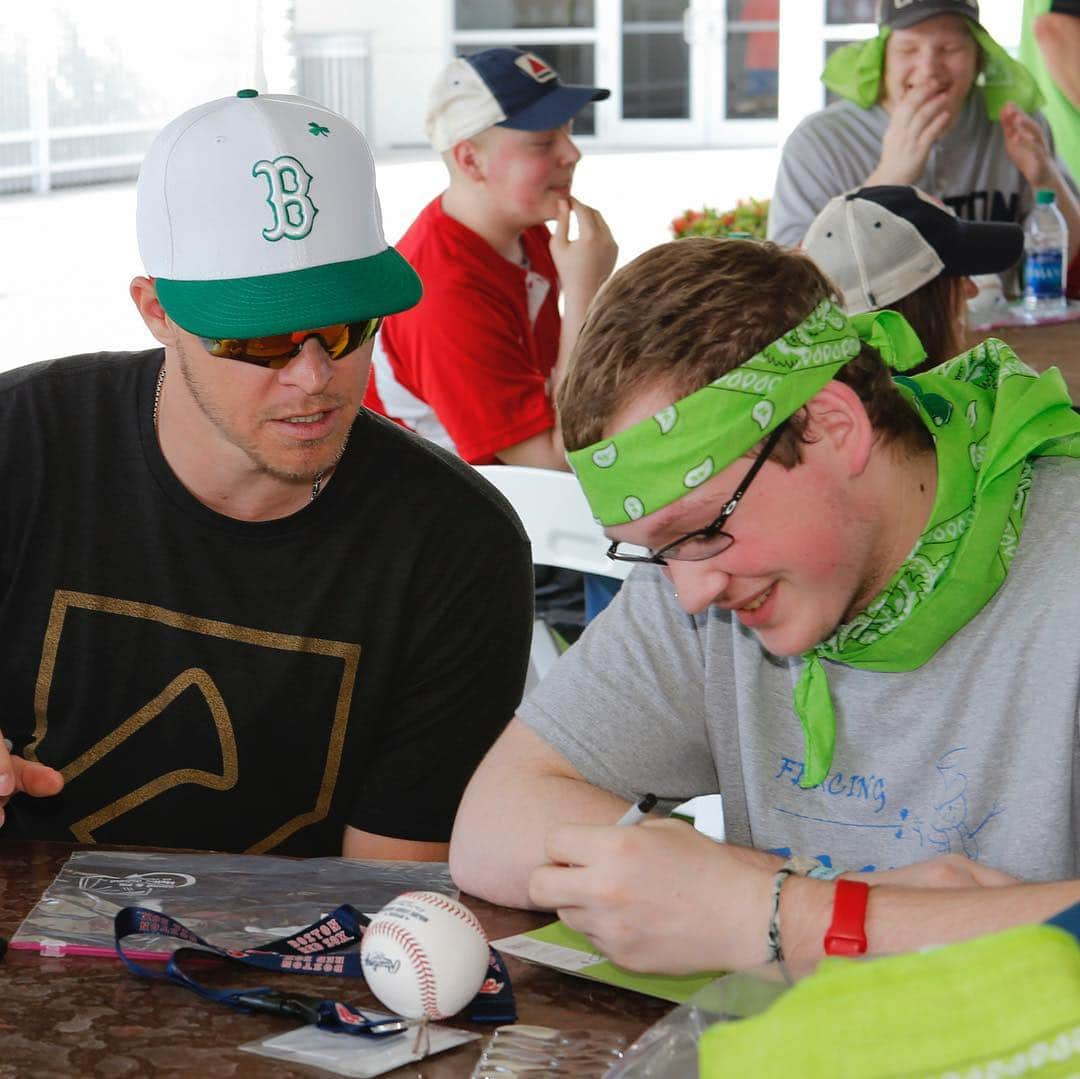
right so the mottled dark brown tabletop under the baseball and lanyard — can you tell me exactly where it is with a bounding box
[0,839,673,1079]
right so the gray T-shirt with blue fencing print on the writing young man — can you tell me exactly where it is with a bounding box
[519,458,1080,880]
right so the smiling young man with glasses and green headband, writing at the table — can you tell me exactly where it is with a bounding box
[450,239,1080,973]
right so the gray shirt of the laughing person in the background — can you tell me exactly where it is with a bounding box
[769,93,1069,246]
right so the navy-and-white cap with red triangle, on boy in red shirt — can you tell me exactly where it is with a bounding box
[426,48,611,152]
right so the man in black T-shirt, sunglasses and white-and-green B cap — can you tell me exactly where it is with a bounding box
[0,90,531,860]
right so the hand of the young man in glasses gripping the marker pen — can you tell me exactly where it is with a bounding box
[529,820,781,974]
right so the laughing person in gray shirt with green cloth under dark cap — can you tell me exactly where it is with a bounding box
[769,0,1080,287]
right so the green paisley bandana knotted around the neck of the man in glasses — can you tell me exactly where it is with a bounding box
[794,338,1080,787]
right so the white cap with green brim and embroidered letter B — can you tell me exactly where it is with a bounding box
[137,90,421,338]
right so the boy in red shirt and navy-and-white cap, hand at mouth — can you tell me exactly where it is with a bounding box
[365,48,617,469]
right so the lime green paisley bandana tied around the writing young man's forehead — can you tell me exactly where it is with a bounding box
[567,299,926,527]
